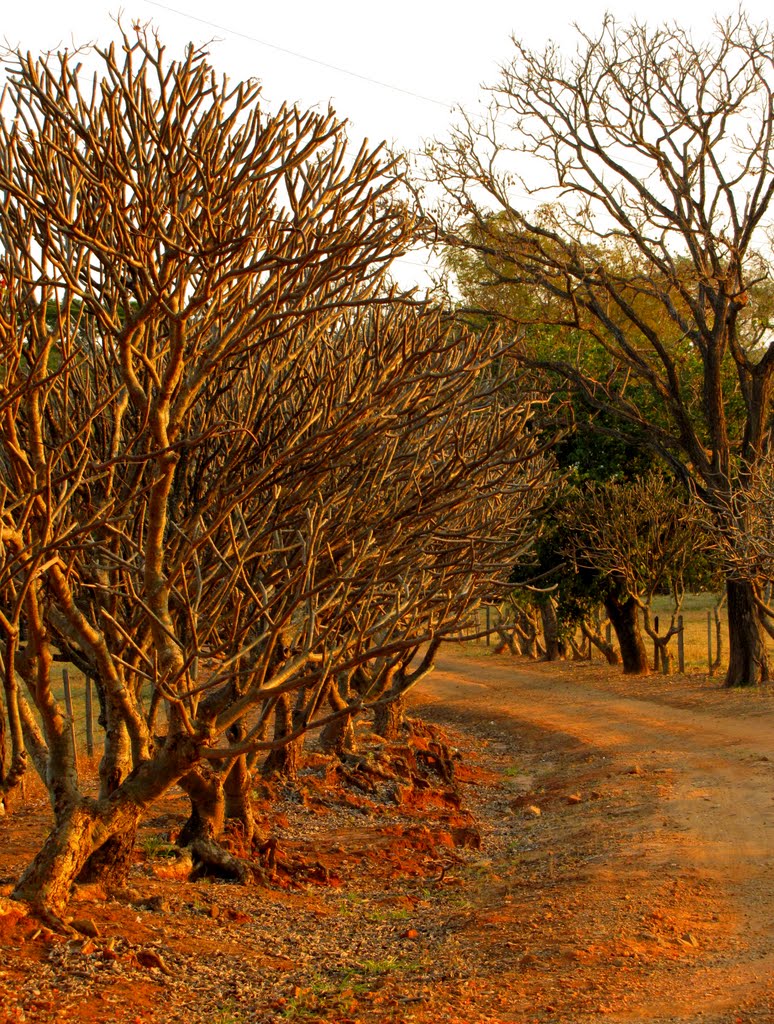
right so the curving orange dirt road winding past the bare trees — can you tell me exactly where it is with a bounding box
[418,654,774,1024]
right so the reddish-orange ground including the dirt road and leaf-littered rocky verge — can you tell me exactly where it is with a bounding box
[0,650,774,1024]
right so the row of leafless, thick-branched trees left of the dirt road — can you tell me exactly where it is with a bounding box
[0,33,549,914]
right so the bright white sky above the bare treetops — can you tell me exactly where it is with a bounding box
[0,0,770,286]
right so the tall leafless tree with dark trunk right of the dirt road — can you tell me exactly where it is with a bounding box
[429,12,774,685]
